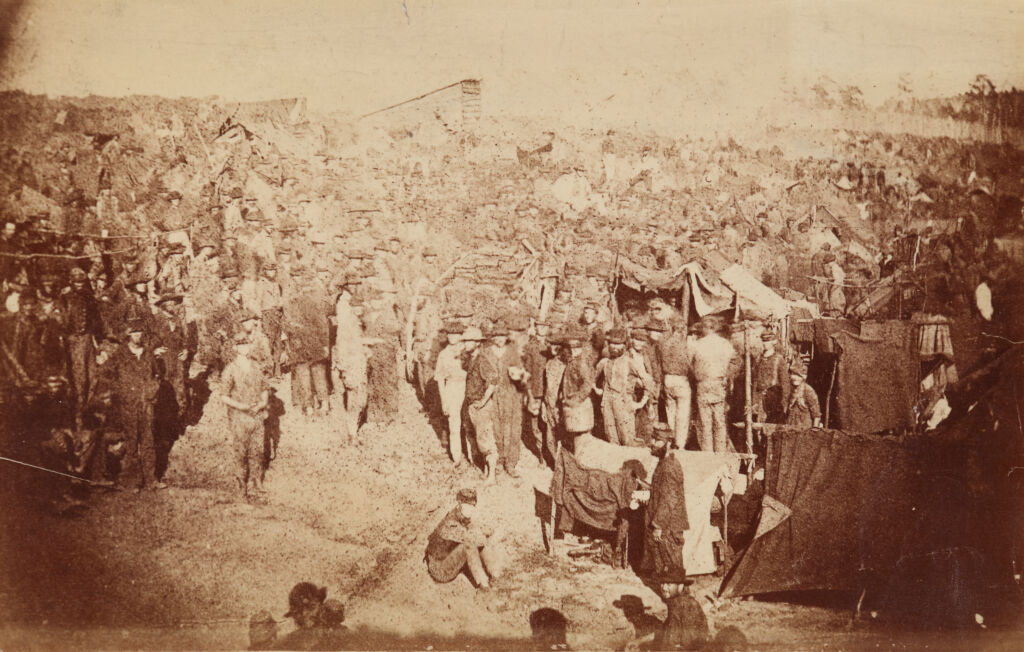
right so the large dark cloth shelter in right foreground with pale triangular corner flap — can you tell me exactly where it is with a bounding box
[720,428,988,597]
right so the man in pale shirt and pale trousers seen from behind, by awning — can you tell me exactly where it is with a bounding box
[693,316,739,452]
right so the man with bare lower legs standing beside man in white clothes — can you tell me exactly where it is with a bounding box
[466,329,505,483]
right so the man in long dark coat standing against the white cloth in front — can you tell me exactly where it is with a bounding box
[642,423,690,576]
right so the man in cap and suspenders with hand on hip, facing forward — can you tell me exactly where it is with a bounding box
[596,327,649,446]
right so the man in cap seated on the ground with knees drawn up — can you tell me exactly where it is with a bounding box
[426,489,502,589]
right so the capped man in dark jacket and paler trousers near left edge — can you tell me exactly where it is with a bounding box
[65,267,103,421]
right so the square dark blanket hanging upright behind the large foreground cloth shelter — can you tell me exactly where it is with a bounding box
[831,323,921,433]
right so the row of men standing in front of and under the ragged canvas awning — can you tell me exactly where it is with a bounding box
[433,299,821,482]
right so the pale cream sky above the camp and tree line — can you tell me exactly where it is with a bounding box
[0,0,1024,125]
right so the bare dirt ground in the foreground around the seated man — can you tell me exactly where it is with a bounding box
[0,380,1024,650]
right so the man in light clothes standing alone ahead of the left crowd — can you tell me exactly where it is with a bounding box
[220,331,270,498]
